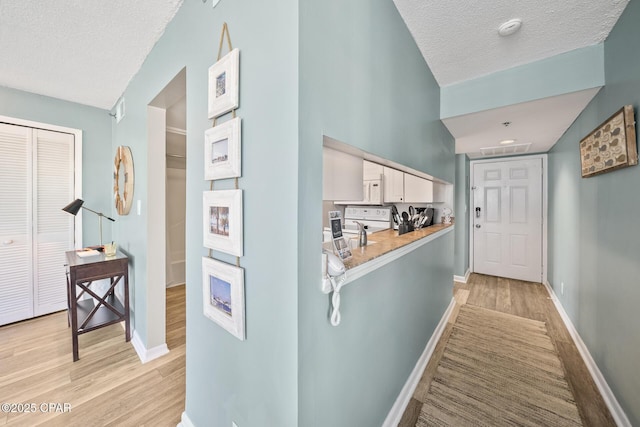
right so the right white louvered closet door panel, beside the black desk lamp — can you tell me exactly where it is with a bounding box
[33,129,74,316]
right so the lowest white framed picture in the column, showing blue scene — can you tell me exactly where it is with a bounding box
[202,257,245,341]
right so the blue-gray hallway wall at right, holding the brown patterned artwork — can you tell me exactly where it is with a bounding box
[549,0,640,425]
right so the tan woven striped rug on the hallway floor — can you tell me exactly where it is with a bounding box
[416,304,582,427]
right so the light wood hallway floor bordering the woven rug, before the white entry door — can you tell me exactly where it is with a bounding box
[399,274,616,427]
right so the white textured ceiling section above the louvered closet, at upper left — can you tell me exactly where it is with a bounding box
[0,0,182,109]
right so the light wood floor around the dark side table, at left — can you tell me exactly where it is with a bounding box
[0,285,185,427]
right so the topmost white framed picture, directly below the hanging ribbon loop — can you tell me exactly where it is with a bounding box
[209,49,240,119]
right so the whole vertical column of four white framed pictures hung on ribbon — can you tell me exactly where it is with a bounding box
[202,23,245,341]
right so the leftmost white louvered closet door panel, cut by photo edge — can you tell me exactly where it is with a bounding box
[0,123,33,325]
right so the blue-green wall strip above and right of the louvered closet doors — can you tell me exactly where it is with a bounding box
[0,87,115,246]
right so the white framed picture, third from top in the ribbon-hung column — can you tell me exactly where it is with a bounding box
[202,190,243,256]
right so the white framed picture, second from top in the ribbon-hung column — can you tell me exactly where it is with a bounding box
[204,117,242,180]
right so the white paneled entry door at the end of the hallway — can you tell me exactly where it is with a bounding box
[471,158,543,282]
